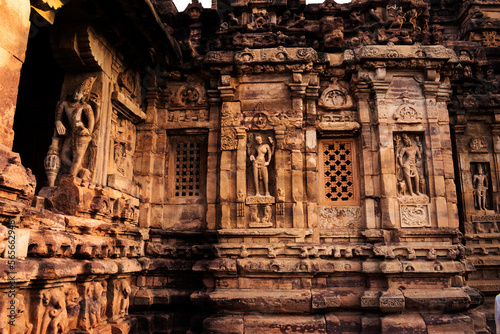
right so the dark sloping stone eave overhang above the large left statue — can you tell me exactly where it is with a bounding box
[48,0,181,69]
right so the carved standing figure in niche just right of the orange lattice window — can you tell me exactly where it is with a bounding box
[394,133,425,196]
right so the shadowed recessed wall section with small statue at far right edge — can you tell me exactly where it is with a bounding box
[450,2,500,319]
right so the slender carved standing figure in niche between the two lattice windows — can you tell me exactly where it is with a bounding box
[248,134,274,196]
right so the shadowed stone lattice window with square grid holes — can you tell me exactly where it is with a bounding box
[174,142,201,197]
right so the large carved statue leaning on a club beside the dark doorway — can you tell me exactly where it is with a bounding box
[45,77,99,187]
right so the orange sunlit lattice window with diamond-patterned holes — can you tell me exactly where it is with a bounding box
[321,140,356,204]
